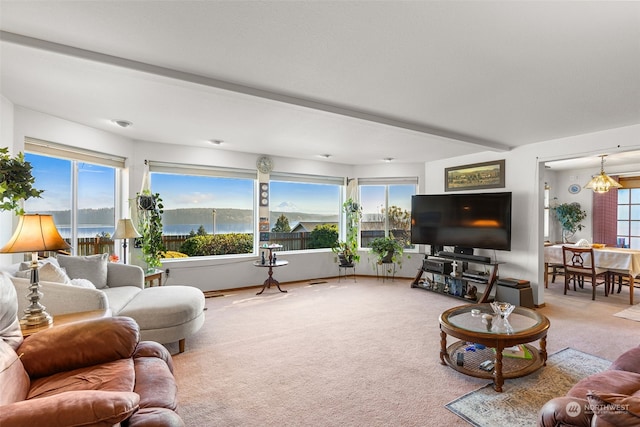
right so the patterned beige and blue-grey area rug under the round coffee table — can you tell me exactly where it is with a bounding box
[445,348,611,427]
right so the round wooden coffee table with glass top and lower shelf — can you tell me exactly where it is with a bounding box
[440,304,549,392]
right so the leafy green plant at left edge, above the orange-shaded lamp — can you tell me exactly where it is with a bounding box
[0,147,44,215]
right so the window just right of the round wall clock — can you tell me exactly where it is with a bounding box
[269,174,343,250]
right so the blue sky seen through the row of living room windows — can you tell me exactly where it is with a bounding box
[25,153,414,214]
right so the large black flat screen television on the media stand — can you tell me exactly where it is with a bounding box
[411,192,511,251]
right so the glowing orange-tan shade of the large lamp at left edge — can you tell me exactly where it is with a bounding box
[0,214,71,253]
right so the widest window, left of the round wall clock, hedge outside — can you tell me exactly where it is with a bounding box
[149,162,256,257]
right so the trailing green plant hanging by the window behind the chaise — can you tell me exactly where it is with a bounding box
[137,190,166,271]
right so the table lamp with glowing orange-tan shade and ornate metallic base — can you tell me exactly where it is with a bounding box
[0,214,71,329]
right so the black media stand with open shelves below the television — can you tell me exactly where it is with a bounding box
[411,252,500,304]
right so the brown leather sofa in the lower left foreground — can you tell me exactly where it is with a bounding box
[0,273,184,427]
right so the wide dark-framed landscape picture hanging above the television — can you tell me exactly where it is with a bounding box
[444,159,505,191]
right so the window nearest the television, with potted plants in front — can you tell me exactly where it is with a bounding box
[359,178,417,248]
